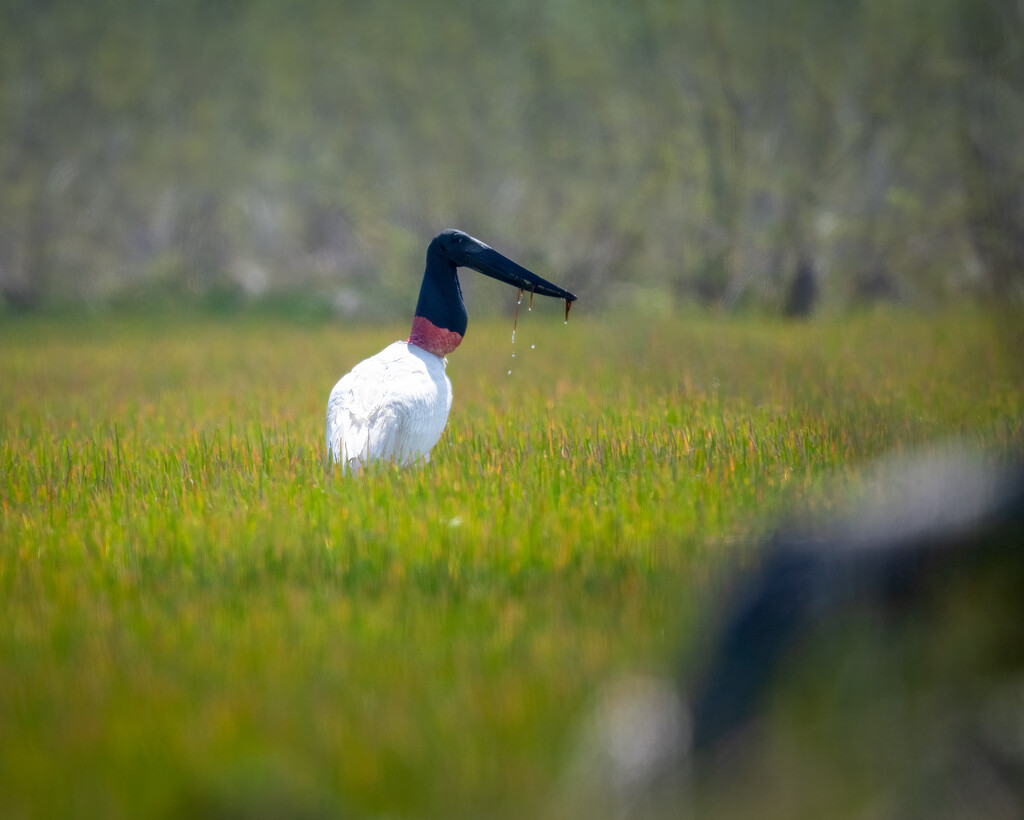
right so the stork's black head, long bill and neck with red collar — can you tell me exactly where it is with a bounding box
[409,228,575,356]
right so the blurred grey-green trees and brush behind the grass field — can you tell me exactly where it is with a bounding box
[0,0,1024,315]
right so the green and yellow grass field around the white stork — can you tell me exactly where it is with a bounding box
[0,305,1024,818]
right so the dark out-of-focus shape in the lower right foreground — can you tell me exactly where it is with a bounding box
[562,449,1024,820]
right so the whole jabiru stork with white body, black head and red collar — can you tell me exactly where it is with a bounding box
[327,229,575,473]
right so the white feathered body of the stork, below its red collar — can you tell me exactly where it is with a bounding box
[327,342,452,472]
